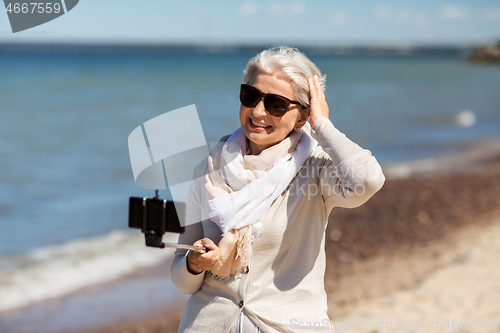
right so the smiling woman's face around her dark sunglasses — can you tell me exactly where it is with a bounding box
[240,72,308,155]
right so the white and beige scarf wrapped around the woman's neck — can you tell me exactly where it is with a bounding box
[205,123,317,278]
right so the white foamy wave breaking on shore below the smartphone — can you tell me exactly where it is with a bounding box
[0,230,177,312]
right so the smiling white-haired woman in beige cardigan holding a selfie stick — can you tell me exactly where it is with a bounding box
[172,47,385,333]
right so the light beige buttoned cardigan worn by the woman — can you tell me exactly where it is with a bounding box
[172,117,385,333]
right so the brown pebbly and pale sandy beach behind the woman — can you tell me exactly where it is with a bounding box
[1,146,500,333]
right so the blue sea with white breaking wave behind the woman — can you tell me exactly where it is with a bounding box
[0,49,500,311]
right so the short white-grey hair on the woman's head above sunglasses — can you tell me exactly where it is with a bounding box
[243,46,326,108]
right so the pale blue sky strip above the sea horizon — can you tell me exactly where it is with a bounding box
[0,0,500,45]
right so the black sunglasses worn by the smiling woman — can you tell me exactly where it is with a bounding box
[240,84,303,117]
